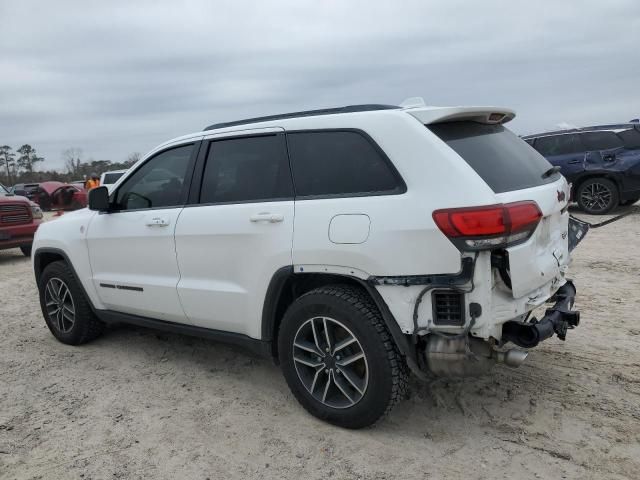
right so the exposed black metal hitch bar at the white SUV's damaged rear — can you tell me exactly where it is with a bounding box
[502,280,580,348]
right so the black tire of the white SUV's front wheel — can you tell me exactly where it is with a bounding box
[38,261,104,345]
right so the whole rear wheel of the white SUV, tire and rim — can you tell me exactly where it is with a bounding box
[278,285,407,428]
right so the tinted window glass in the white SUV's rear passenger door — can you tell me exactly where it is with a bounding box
[200,135,293,203]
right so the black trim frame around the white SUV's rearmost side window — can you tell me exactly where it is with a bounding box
[286,128,407,201]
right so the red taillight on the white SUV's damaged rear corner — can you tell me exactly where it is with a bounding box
[433,200,542,250]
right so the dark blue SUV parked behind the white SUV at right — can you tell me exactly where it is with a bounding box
[523,123,640,214]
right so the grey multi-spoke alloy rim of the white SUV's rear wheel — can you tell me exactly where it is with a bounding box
[293,317,369,408]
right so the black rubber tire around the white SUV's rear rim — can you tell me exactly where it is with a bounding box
[278,285,407,428]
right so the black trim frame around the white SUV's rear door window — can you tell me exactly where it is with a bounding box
[185,131,295,208]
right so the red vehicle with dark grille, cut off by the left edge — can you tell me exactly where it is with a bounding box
[0,185,42,257]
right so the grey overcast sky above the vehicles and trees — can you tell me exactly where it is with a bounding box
[0,0,640,168]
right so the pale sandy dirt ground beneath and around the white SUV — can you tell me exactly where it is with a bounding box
[0,211,640,480]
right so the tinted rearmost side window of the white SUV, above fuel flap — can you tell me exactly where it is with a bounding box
[287,131,404,196]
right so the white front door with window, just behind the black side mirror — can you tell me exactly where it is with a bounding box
[87,142,198,322]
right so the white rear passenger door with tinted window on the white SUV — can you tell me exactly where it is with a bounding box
[175,128,294,338]
